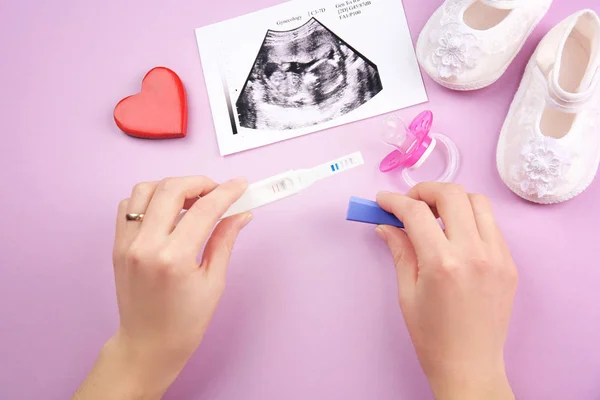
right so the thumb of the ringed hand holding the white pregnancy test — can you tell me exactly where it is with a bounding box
[202,213,252,282]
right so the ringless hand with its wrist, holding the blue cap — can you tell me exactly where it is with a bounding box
[376,183,518,400]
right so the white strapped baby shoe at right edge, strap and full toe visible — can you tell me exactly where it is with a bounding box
[497,10,600,204]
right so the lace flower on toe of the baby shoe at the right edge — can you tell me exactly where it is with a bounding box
[514,136,571,198]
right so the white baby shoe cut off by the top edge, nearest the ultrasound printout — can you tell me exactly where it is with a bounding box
[417,0,552,90]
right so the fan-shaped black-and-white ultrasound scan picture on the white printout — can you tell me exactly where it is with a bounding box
[236,18,383,130]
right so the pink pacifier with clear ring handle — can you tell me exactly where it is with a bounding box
[379,110,460,186]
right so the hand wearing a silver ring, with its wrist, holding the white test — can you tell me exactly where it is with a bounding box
[73,176,252,400]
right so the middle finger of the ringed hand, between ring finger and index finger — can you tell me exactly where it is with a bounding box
[142,176,217,236]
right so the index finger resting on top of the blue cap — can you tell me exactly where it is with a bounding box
[377,193,449,258]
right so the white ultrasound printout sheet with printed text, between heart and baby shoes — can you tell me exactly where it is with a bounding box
[196,0,427,155]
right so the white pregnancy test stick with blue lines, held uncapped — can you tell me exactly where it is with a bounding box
[223,152,365,218]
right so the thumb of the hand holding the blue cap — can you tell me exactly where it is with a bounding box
[375,225,419,298]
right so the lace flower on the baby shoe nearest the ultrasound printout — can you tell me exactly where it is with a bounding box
[431,23,481,78]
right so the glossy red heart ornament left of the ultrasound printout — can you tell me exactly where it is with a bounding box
[114,67,187,139]
